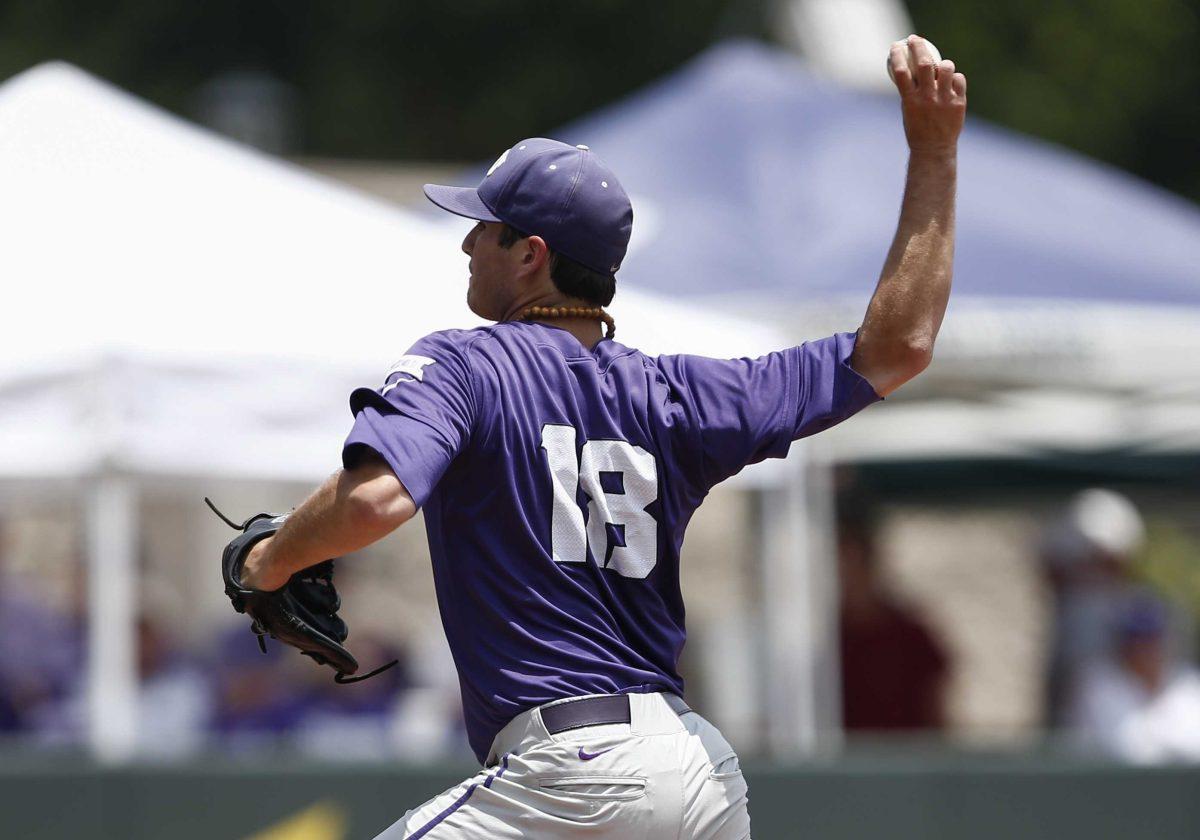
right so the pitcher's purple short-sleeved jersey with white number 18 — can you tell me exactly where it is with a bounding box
[343,322,878,762]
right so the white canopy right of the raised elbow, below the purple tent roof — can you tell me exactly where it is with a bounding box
[814,300,1200,461]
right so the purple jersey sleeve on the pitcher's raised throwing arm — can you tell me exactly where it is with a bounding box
[659,332,880,490]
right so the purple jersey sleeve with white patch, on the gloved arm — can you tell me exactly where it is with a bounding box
[342,332,475,508]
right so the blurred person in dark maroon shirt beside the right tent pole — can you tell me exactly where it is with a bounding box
[838,496,948,731]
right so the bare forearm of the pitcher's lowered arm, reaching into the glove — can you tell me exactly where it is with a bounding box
[242,461,416,589]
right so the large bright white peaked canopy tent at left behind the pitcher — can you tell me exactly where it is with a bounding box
[0,64,816,760]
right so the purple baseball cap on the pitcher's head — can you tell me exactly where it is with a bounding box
[425,137,634,274]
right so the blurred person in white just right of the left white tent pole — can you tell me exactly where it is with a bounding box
[137,617,212,758]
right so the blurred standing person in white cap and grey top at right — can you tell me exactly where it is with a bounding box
[1043,488,1145,726]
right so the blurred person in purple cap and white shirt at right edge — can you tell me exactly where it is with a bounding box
[1067,596,1200,764]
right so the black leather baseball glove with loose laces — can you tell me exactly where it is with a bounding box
[204,497,396,683]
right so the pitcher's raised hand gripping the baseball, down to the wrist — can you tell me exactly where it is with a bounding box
[888,35,967,155]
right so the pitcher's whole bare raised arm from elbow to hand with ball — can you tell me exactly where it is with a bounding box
[850,36,967,396]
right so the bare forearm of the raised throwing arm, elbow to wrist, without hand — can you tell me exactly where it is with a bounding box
[856,150,958,390]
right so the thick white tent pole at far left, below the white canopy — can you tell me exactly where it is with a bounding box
[86,472,138,763]
